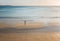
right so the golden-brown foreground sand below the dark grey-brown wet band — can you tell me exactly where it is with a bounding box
[0,32,60,41]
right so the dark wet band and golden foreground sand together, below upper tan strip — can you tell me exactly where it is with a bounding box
[0,27,60,41]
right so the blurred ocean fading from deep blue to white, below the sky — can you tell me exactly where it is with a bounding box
[0,6,60,23]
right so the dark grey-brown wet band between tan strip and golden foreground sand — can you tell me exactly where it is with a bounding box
[0,26,60,33]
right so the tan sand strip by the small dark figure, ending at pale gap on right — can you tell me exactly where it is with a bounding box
[0,22,45,28]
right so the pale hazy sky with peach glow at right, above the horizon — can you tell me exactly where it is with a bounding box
[0,0,60,5]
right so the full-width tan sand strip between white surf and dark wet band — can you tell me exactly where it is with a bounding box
[0,22,60,28]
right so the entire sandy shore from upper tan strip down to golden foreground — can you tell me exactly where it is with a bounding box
[0,23,60,41]
